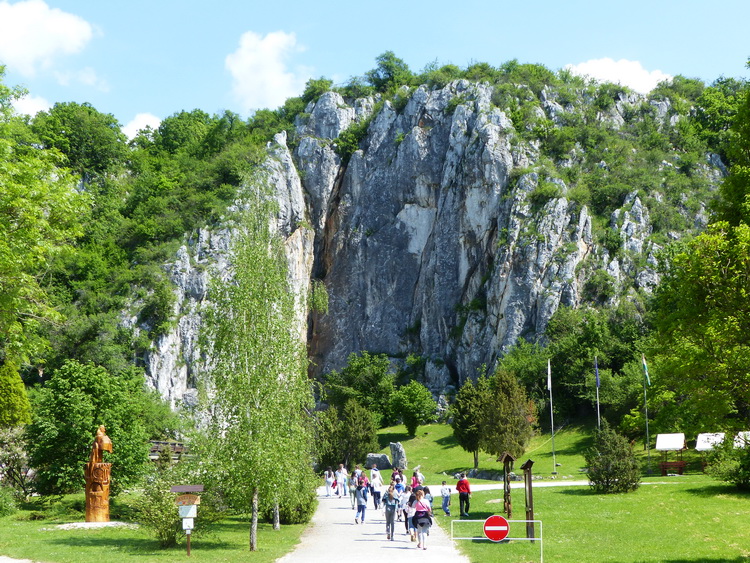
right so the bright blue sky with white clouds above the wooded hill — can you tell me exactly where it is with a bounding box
[0,0,750,137]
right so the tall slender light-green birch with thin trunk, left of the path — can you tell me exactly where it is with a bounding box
[198,187,312,551]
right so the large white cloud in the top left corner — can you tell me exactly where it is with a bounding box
[0,0,94,77]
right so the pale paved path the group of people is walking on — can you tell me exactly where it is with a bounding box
[278,486,469,563]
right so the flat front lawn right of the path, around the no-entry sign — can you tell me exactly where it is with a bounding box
[436,475,750,563]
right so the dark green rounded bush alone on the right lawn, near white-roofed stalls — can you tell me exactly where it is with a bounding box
[584,420,641,493]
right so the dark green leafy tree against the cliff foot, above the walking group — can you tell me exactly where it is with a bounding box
[324,352,395,426]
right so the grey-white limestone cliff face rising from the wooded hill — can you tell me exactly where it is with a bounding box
[144,81,720,406]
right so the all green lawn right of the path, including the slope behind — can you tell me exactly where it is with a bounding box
[379,424,750,563]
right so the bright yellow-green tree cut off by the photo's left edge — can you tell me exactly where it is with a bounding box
[0,67,87,366]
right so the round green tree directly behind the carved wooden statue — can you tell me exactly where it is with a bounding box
[26,361,157,494]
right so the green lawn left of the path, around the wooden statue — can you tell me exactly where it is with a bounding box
[0,503,304,563]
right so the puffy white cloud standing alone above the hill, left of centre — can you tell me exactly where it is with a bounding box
[225,31,312,112]
